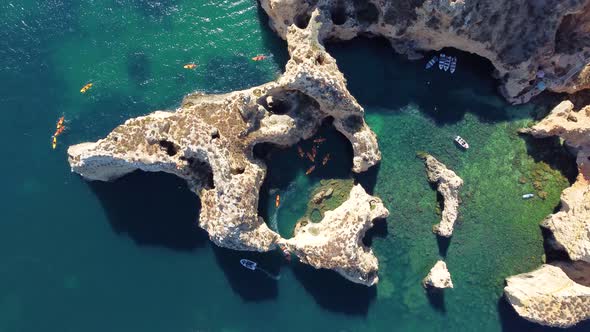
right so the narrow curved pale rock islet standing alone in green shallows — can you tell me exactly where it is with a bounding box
[424,155,463,237]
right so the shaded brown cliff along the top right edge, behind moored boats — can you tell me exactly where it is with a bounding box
[260,0,590,103]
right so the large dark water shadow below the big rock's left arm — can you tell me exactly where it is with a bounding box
[88,171,208,251]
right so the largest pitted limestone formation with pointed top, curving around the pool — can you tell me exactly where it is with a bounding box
[68,13,381,251]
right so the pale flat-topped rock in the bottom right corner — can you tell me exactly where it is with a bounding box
[504,264,590,327]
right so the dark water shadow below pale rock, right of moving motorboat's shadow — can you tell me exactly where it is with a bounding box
[293,264,377,316]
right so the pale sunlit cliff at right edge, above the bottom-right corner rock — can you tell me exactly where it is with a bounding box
[525,101,590,262]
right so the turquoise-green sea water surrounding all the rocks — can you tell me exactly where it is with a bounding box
[0,0,588,332]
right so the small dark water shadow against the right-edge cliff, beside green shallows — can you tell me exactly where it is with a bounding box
[521,135,578,184]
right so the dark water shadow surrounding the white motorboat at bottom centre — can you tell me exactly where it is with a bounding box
[212,245,282,301]
